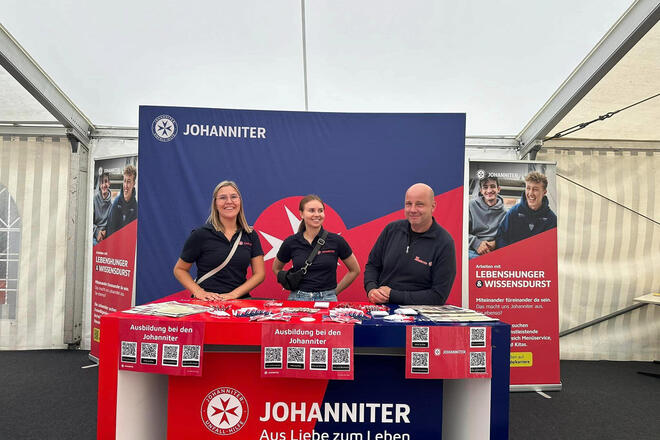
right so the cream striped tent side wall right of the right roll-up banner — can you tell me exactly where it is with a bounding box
[537,141,660,361]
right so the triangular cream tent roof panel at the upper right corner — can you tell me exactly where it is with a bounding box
[548,23,660,141]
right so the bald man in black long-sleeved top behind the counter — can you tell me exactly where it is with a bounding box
[364,183,456,305]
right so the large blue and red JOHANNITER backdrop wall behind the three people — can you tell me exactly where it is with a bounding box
[136,106,465,305]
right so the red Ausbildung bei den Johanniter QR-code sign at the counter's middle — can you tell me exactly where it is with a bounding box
[261,322,354,380]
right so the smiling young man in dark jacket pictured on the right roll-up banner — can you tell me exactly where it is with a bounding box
[495,171,557,249]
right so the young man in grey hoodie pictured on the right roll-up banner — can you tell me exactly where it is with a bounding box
[468,176,506,259]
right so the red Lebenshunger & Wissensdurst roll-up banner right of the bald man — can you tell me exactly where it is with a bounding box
[468,161,561,390]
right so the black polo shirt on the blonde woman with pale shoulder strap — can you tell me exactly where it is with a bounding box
[181,223,264,293]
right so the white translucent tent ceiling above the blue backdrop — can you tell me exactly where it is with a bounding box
[0,0,632,135]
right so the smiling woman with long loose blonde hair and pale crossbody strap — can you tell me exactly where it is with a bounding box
[174,180,266,301]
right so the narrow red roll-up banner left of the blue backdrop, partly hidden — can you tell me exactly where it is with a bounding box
[90,156,138,358]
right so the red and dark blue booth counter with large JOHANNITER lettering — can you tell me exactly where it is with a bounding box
[97,296,510,440]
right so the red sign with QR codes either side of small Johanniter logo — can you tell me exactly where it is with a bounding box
[406,325,492,379]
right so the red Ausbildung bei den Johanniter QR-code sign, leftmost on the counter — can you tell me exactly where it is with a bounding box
[119,317,204,376]
